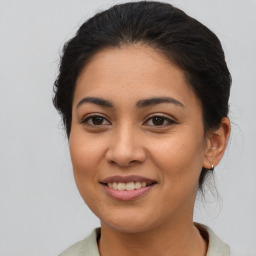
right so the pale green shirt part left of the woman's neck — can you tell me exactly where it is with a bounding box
[59,228,100,256]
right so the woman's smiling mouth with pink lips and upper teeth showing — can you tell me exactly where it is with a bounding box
[100,175,157,200]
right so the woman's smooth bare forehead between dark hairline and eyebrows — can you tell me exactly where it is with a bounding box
[74,45,197,107]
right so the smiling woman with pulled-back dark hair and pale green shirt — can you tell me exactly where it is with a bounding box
[54,1,231,256]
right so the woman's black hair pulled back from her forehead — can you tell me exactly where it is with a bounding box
[53,1,231,189]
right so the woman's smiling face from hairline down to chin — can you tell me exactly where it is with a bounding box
[69,45,213,232]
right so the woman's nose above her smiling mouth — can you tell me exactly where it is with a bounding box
[106,126,146,167]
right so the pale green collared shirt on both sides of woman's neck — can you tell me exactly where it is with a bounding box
[59,224,230,256]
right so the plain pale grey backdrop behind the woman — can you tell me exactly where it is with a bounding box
[0,0,256,256]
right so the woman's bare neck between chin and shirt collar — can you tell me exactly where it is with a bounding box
[99,221,207,256]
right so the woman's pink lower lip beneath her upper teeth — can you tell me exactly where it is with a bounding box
[102,185,154,201]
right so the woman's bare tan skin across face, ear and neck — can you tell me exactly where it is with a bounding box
[69,44,230,256]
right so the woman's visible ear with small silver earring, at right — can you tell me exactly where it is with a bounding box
[203,117,230,169]
